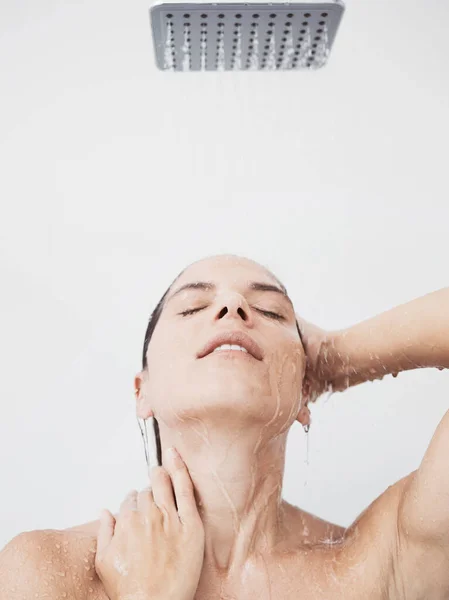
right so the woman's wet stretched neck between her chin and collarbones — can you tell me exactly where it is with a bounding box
[159,422,287,575]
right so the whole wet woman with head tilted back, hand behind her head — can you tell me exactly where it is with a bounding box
[0,256,449,600]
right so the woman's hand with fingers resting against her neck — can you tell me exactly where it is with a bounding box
[95,453,204,600]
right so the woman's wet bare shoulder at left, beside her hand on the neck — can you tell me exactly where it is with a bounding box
[0,530,107,600]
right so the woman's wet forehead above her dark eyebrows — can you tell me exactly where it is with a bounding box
[173,255,282,288]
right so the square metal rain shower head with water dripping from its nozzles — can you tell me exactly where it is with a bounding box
[150,0,345,71]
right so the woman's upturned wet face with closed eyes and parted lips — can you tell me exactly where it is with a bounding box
[137,256,305,435]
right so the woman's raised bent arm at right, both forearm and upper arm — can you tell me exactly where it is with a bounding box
[306,288,449,600]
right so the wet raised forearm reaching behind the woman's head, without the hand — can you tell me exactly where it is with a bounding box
[317,288,449,391]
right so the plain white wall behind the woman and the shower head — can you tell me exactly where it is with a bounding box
[0,0,449,547]
